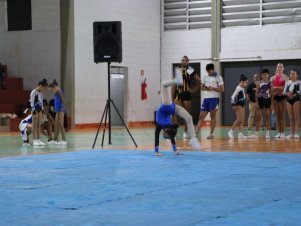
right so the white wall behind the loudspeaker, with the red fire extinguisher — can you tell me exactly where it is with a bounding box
[74,0,160,124]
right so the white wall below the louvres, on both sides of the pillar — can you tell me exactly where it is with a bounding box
[161,23,301,76]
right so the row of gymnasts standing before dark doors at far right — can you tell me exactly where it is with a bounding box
[228,63,301,139]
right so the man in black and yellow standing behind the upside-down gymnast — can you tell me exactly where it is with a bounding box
[172,56,199,139]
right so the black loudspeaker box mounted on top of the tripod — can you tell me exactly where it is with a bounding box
[93,21,122,63]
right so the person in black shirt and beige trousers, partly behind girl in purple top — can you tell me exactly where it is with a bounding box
[246,74,260,130]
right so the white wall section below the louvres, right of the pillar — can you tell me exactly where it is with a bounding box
[221,23,301,60]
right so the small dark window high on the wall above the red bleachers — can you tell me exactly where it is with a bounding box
[7,0,32,31]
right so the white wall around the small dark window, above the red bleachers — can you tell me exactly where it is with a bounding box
[0,0,61,90]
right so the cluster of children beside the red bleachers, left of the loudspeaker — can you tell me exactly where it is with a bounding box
[19,79,67,146]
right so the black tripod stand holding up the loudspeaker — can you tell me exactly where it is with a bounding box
[92,62,137,149]
